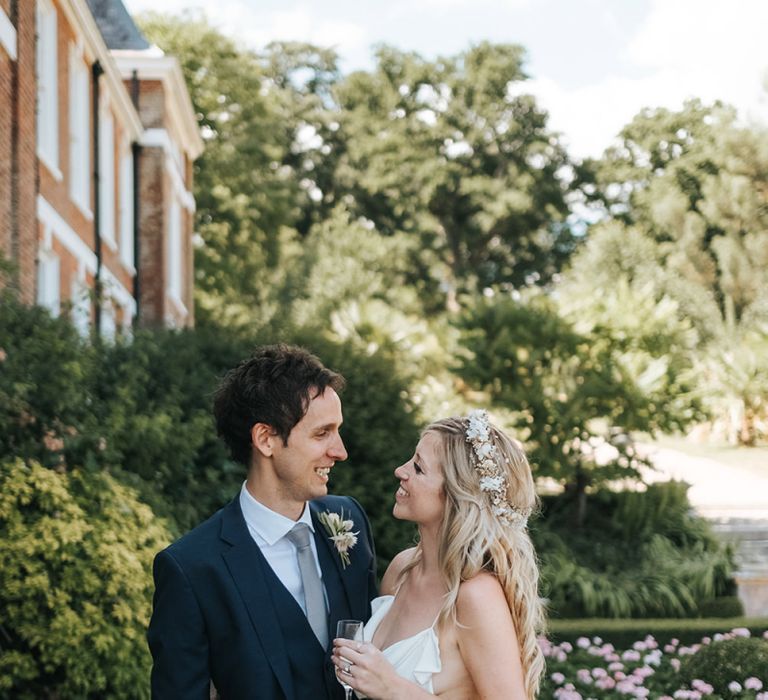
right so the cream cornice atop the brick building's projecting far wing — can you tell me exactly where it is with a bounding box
[111,47,204,160]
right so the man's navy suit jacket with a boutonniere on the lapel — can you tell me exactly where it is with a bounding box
[147,496,376,700]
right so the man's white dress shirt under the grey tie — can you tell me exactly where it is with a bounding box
[240,482,328,615]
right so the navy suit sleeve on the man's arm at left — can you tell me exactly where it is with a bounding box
[147,550,210,700]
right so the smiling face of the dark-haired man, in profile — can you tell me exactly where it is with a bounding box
[272,387,347,514]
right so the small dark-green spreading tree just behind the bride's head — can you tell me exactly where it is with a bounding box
[458,296,670,524]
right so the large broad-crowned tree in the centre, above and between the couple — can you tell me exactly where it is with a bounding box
[333,43,572,307]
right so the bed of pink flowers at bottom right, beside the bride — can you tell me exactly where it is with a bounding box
[540,628,768,700]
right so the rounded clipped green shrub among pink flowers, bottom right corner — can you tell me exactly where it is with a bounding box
[680,637,768,698]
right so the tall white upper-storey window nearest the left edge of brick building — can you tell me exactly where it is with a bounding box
[36,0,63,180]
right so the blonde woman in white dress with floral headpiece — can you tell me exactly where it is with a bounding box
[332,411,544,700]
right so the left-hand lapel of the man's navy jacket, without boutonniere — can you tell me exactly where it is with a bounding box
[221,498,294,698]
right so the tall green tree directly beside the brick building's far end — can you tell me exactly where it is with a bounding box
[140,13,302,325]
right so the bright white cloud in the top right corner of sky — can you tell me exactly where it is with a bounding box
[528,0,768,157]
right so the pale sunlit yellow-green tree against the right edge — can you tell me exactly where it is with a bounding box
[584,102,768,444]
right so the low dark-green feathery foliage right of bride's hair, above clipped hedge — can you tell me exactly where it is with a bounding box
[532,482,732,617]
